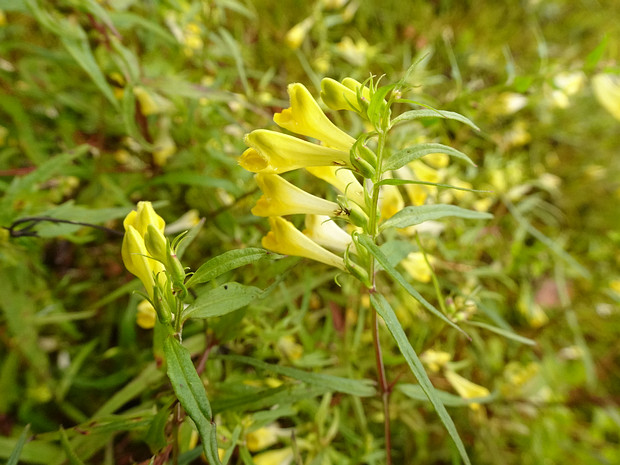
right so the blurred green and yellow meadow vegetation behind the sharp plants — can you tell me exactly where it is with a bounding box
[0,0,620,465]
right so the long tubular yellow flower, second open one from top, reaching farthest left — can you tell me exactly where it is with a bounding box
[239,129,350,174]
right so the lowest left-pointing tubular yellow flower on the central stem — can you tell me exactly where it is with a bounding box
[262,216,345,270]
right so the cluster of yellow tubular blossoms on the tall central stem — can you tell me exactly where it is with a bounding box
[239,78,368,270]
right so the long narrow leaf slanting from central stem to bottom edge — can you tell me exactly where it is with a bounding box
[370,293,471,465]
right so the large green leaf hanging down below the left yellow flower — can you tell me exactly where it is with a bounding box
[164,335,221,465]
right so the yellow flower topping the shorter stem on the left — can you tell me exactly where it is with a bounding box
[121,202,166,298]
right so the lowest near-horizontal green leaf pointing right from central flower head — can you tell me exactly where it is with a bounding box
[379,204,493,231]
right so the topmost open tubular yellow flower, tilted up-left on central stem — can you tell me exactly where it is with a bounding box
[273,83,355,152]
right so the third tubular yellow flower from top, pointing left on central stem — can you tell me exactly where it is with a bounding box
[252,173,344,216]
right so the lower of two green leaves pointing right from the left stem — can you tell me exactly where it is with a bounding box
[181,283,263,321]
